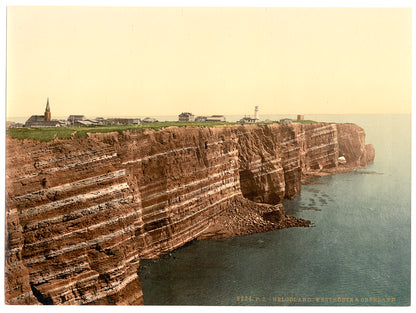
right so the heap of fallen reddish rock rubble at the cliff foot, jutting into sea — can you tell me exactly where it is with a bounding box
[197,196,310,240]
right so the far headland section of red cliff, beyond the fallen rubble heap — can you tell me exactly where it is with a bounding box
[238,123,375,204]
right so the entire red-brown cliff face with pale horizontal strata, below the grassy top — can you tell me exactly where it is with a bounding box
[5,123,374,304]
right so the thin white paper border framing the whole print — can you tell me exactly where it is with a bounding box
[0,0,416,313]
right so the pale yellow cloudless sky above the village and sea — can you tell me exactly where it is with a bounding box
[6,6,412,118]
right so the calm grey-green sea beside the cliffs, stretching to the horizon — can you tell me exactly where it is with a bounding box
[138,115,411,306]
